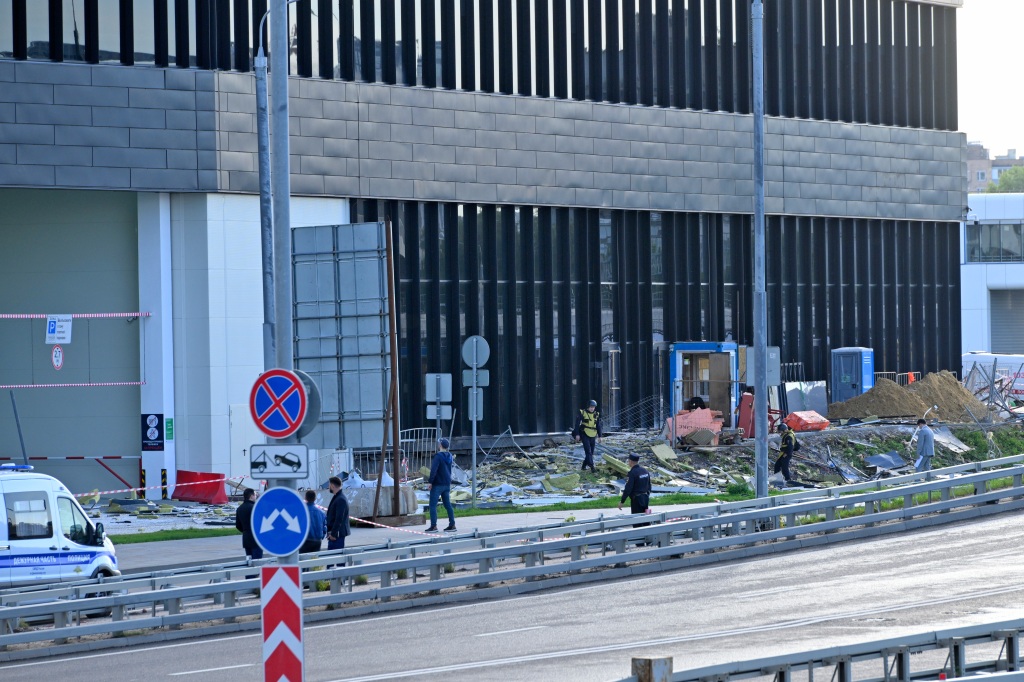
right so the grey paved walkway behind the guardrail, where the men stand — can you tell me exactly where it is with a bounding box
[117,500,711,572]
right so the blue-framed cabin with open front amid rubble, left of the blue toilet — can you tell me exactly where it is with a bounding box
[669,341,740,426]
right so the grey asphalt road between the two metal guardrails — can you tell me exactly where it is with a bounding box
[0,514,1024,682]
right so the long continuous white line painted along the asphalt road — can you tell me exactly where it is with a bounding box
[323,586,1024,682]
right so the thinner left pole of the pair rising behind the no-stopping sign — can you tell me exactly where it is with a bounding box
[255,11,278,371]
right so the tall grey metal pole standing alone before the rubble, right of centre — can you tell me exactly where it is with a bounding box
[751,0,768,498]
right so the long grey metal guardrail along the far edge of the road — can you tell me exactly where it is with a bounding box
[6,457,1024,659]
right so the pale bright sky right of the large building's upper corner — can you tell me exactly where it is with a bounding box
[956,0,1024,157]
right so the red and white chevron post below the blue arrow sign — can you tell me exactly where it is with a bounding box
[260,564,305,682]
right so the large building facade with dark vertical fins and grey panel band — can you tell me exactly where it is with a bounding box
[0,0,966,489]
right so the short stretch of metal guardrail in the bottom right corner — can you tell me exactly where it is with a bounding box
[620,620,1024,682]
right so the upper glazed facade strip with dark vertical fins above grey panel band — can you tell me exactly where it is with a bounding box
[0,0,957,130]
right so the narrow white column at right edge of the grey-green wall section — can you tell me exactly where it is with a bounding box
[138,193,177,500]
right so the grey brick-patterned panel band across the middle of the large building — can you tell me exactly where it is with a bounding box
[0,62,967,220]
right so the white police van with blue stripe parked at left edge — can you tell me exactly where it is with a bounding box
[0,464,121,588]
